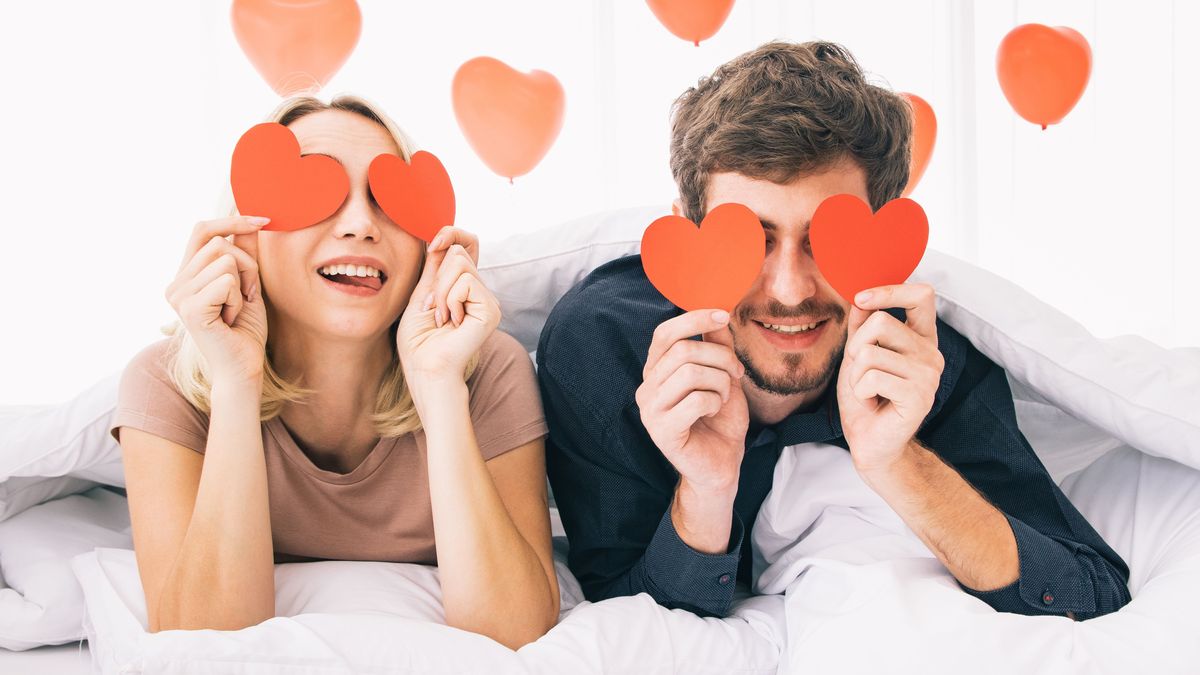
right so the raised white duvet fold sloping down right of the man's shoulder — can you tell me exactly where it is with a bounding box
[912,251,1200,468]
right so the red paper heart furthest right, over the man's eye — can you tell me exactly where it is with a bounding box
[809,195,929,303]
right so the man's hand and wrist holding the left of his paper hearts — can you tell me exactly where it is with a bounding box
[636,310,750,554]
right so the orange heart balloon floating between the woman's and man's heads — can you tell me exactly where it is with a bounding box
[451,56,566,181]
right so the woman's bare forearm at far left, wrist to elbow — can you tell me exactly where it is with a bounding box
[151,374,275,629]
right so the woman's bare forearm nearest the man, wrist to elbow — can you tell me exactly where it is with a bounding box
[419,380,558,649]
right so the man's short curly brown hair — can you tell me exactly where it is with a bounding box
[671,41,912,222]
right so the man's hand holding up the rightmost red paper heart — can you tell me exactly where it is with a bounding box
[838,283,944,480]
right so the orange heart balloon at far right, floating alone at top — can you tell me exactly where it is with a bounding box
[996,24,1092,129]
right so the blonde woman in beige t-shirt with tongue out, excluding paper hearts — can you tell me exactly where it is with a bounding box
[113,96,558,649]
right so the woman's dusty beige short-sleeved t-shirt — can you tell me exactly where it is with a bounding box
[112,330,547,565]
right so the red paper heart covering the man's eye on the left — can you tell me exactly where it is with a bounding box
[642,203,767,311]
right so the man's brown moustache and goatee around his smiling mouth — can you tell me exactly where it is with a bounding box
[733,294,846,396]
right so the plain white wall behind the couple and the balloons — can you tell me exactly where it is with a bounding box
[0,0,1200,404]
